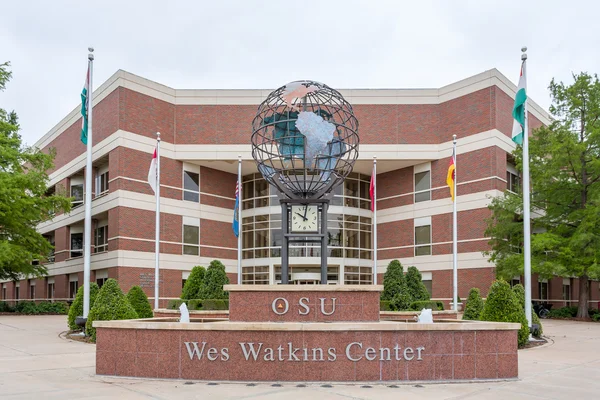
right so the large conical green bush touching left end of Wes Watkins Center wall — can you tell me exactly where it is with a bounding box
[85,278,138,342]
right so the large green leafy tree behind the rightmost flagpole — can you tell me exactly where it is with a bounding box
[486,73,600,318]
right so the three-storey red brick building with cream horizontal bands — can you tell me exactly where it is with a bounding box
[0,70,600,304]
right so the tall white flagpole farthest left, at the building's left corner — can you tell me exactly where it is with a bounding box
[83,47,94,318]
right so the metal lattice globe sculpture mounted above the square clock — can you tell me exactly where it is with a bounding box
[252,81,359,199]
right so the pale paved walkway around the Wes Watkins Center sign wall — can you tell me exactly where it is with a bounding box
[0,315,600,400]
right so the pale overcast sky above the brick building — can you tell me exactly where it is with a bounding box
[0,0,600,144]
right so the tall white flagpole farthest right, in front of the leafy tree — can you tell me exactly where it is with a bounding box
[521,47,532,327]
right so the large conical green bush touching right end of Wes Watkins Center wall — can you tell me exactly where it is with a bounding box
[481,281,529,346]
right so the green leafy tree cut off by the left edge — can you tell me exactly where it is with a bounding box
[0,62,71,280]
